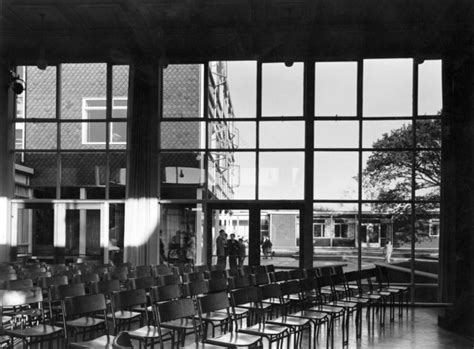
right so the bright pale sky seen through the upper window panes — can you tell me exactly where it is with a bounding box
[224,59,442,200]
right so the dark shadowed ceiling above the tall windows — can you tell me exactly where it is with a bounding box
[0,0,474,64]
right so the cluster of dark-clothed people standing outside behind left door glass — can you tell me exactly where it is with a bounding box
[216,229,245,268]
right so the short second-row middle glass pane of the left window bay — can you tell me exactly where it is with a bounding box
[61,122,106,149]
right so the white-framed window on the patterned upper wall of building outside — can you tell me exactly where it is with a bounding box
[82,97,127,144]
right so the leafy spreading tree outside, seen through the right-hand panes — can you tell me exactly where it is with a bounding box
[363,119,441,243]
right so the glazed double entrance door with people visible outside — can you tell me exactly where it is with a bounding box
[207,203,302,268]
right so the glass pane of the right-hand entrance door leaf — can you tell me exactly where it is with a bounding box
[260,210,300,267]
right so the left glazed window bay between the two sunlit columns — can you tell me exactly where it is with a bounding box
[15,63,129,255]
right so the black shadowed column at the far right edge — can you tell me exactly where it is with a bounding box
[439,57,474,334]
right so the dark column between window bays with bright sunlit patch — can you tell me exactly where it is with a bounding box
[124,63,160,265]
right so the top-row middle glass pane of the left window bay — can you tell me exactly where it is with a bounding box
[61,63,107,119]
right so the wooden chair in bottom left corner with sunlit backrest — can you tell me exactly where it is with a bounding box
[0,287,63,348]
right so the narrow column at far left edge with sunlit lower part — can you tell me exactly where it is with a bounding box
[0,61,16,262]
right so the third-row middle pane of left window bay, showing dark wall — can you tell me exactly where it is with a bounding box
[61,153,106,199]
